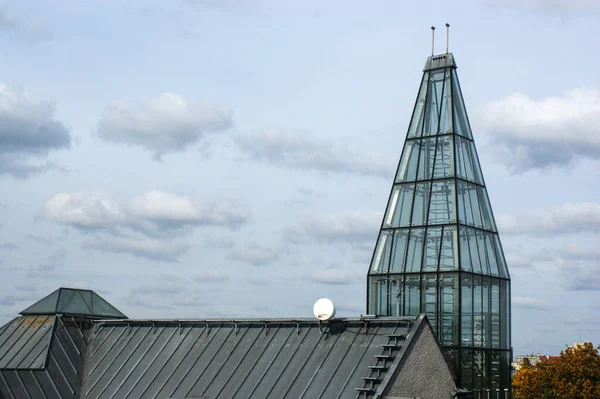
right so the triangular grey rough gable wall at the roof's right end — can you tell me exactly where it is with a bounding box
[384,323,456,399]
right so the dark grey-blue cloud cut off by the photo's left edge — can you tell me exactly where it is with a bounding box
[0,83,71,178]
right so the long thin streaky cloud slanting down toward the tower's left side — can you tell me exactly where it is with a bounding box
[234,129,394,177]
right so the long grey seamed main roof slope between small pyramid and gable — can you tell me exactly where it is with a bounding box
[81,318,422,399]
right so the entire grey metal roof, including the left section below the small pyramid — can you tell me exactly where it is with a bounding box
[0,315,450,399]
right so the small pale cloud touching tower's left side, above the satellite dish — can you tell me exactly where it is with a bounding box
[285,211,382,245]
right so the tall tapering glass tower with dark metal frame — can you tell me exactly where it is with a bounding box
[367,53,512,397]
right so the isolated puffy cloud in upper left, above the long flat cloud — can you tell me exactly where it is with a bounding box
[98,93,233,159]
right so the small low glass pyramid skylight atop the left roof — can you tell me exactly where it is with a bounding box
[21,288,127,319]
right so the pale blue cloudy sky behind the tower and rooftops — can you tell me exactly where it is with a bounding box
[0,0,600,354]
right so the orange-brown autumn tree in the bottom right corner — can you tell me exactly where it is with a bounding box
[513,342,600,399]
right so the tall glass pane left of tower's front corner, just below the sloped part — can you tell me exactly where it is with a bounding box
[438,274,458,345]
